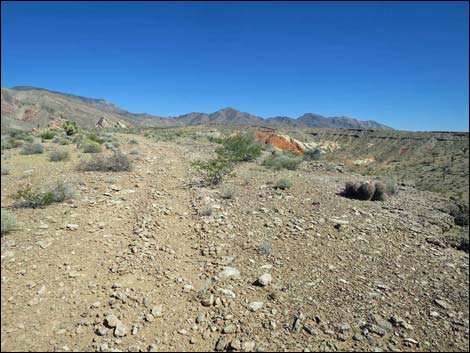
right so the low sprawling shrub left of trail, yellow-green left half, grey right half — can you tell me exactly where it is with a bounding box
[11,181,75,208]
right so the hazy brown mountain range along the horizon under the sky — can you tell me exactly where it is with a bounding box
[1,86,391,130]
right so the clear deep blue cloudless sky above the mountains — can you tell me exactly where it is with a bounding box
[1,1,469,131]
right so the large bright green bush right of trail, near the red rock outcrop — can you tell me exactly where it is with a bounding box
[216,136,261,162]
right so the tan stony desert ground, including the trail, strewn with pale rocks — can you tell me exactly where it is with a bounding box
[1,132,469,351]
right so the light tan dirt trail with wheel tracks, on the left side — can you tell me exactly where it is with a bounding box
[1,139,203,351]
